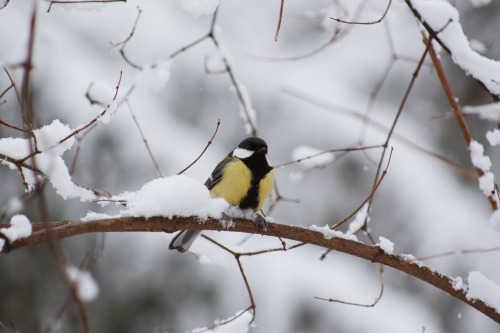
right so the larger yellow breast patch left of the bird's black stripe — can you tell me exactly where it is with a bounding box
[210,159,252,206]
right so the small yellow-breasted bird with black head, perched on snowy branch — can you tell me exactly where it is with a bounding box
[169,137,274,252]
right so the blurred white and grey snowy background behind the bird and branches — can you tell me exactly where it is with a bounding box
[0,0,500,333]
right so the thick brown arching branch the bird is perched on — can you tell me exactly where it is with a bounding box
[0,216,500,323]
